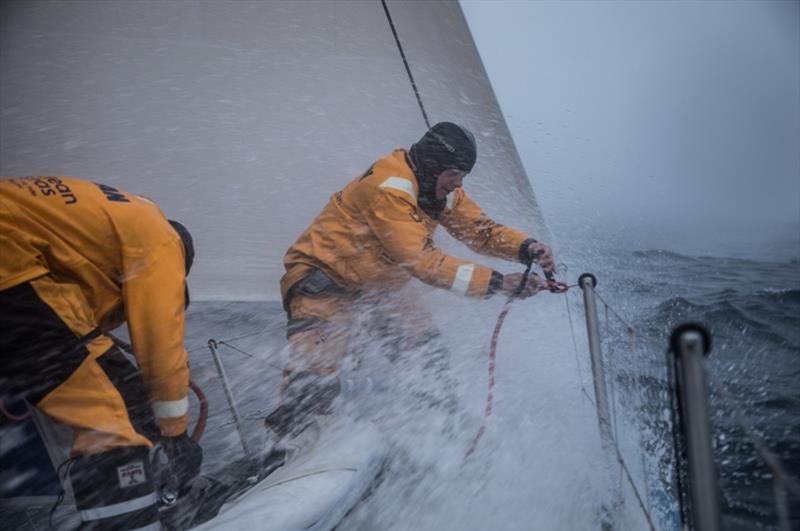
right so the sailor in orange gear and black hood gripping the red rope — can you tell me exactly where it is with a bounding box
[267,122,555,437]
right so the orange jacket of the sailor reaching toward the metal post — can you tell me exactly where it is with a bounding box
[281,149,527,301]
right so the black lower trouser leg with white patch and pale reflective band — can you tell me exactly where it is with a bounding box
[70,446,160,530]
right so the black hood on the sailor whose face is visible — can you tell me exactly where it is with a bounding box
[408,122,478,219]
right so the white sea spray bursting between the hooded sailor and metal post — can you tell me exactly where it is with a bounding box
[346,284,637,529]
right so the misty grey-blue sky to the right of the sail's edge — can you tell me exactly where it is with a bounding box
[461,0,800,251]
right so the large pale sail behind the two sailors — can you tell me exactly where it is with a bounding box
[0,0,544,300]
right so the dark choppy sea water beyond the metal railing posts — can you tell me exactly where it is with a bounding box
[564,237,800,529]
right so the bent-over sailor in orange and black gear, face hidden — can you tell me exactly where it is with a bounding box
[0,177,202,529]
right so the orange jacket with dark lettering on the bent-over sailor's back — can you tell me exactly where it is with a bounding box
[0,177,189,435]
